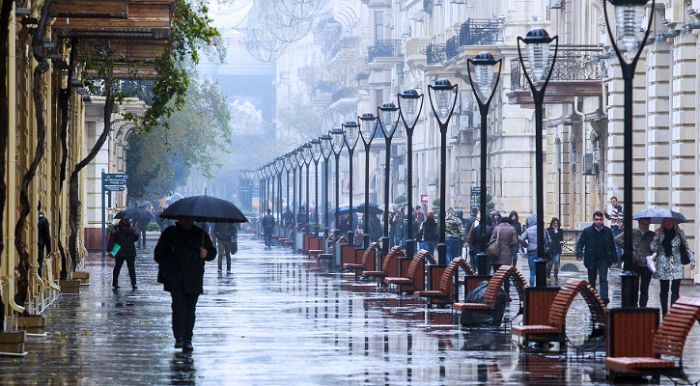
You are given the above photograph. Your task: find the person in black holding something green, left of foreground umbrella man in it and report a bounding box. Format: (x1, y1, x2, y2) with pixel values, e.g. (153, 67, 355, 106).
(107, 218, 139, 291)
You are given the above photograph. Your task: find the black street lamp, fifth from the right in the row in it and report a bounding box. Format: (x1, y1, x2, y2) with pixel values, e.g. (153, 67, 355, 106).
(398, 89, 423, 257)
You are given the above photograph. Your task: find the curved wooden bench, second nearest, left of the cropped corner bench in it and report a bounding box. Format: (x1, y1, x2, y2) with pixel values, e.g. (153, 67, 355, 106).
(512, 278, 607, 349)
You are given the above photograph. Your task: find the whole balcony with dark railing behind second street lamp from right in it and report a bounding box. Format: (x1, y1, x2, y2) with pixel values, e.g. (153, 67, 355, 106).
(508, 46, 606, 105)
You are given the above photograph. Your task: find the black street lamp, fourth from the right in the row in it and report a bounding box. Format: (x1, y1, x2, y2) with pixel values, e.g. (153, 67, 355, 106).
(428, 79, 459, 264)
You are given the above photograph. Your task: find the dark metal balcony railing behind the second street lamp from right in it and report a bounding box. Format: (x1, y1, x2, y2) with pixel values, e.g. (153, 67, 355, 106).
(510, 46, 605, 90)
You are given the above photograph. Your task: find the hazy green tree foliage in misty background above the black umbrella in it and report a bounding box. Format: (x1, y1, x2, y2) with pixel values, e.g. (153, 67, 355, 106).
(127, 79, 231, 200)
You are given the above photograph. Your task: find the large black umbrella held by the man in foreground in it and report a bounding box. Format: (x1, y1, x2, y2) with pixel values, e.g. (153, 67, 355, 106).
(160, 196, 248, 223)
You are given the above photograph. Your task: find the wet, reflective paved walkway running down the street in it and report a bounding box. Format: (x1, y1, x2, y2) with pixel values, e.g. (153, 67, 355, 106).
(0, 234, 700, 385)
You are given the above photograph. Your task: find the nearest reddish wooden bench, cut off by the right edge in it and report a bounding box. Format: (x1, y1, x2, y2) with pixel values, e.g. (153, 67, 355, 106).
(605, 296, 700, 381)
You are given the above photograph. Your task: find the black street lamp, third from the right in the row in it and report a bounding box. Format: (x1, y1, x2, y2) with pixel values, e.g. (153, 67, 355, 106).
(467, 52, 503, 275)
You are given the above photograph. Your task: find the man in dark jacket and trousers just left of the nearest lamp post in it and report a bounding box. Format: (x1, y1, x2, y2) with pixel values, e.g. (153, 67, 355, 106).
(576, 211, 616, 305)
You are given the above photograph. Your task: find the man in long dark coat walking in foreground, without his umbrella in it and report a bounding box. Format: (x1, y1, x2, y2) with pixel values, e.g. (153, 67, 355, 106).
(154, 217, 216, 352)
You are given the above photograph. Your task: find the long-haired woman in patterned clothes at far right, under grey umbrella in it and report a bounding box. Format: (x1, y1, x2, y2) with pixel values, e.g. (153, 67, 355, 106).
(651, 217, 695, 315)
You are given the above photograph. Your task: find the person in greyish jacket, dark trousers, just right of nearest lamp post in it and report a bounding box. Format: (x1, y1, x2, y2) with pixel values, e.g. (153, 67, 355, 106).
(615, 217, 656, 307)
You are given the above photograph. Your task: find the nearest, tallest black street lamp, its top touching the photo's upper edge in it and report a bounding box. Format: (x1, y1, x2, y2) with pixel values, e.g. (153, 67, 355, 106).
(603, 0, 656, 307)
